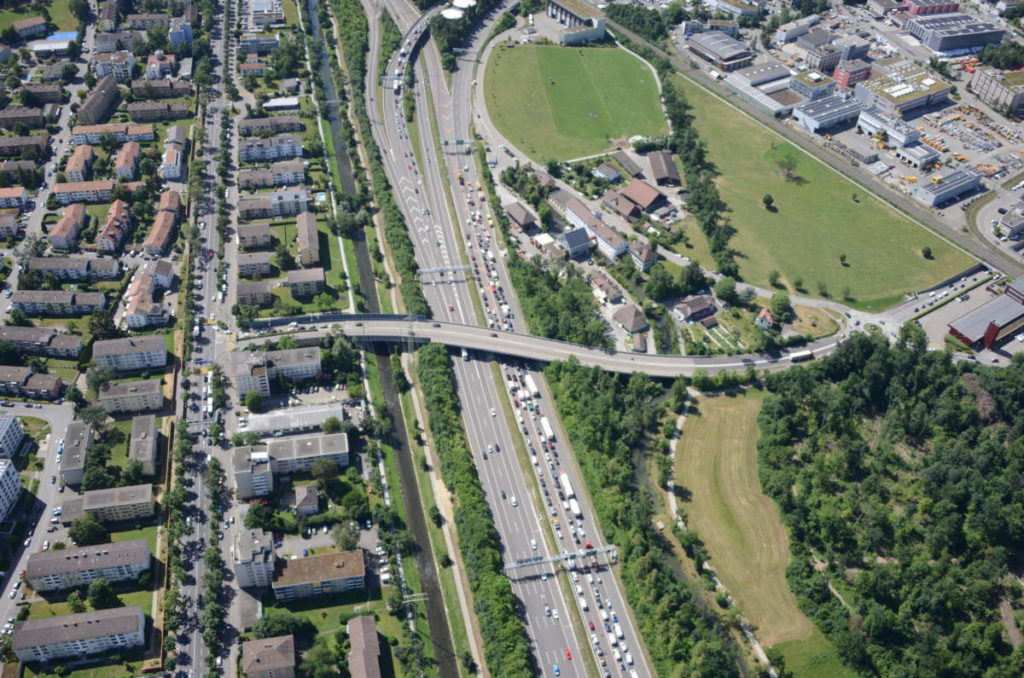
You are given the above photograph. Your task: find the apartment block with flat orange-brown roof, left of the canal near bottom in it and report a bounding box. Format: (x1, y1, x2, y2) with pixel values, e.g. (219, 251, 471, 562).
(272, 549, 367, 602)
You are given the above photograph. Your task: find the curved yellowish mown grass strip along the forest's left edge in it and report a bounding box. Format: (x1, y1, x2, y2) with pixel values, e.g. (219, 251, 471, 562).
(676, 392, 852, 678)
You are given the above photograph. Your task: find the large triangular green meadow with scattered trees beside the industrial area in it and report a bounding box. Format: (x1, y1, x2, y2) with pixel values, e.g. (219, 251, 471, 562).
(676, 76, 971, 310)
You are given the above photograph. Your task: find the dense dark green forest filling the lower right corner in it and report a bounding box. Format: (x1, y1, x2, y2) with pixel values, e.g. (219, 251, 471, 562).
(759, 326, 1024, 678)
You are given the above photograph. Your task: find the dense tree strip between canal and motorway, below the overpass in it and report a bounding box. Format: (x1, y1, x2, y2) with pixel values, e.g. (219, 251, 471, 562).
(417, 344, 538, 678)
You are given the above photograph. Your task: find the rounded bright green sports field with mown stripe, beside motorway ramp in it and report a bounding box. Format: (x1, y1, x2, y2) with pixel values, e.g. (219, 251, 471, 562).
(484, 45, 668, 163)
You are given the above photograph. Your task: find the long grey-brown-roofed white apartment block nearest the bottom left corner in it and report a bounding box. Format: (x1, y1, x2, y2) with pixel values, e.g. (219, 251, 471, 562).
(10, 605, 145, 662)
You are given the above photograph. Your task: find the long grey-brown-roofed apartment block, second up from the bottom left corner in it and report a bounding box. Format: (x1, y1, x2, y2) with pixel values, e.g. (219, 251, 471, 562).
(25, 539, 152, 592)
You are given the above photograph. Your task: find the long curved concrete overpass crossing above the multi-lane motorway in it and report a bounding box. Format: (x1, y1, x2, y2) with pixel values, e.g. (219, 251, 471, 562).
(253, 313, 842, 377)
